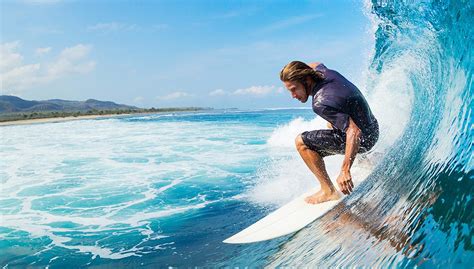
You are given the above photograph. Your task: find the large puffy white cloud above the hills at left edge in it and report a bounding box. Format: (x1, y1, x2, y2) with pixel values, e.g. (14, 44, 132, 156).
(0, 42, 95, 93)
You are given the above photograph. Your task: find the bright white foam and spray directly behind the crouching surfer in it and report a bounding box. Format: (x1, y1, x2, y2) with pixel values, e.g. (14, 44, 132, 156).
(247, 33, 416, 206)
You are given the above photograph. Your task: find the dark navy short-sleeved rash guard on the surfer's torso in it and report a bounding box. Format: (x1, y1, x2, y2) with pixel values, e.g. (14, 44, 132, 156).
(312, 64, 378, 138)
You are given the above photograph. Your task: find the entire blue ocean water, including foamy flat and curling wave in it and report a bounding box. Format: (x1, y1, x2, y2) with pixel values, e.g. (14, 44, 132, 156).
(0, 0, 474, 268)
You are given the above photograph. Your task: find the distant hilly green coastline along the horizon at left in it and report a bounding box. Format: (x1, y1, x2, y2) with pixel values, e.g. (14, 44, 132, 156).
(0, 95, 212, 122)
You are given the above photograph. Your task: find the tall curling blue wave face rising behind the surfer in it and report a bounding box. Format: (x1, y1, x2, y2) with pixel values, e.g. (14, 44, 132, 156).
(270, 0, 474, 268)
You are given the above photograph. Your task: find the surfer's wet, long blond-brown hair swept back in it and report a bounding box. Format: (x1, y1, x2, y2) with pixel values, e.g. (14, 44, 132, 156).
(280, 61, 324, 85)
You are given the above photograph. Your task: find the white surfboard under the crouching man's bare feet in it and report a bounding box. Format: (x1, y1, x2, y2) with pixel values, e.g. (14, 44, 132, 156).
(223, 163, 370, 244)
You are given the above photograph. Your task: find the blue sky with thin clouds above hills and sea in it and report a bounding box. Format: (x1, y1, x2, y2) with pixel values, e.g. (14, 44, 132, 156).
(0, 0, 373, 109)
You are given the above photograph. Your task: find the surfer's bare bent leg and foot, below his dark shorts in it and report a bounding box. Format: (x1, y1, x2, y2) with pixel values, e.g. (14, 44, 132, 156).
(295, 135, 340, 204)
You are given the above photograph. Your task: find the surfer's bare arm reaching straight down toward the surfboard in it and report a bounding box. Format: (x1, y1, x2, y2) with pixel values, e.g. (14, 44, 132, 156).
(337, 117, 362, 194)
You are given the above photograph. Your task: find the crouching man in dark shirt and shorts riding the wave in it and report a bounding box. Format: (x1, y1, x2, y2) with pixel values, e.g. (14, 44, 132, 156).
(280, 61, 379, 204)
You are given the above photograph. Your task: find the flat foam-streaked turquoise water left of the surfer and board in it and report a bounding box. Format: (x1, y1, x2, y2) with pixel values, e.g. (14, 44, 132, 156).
(0, 109, 336, 267)
